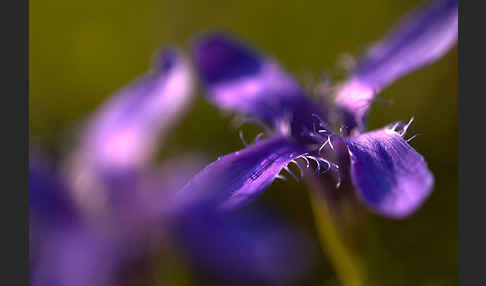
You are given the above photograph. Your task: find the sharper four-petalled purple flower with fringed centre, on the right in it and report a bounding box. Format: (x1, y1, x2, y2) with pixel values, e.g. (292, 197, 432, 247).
(178, 0, 458, 218)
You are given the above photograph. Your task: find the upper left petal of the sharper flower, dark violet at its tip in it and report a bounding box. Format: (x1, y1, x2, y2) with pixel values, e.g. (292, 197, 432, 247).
(193, 34, 325, 136)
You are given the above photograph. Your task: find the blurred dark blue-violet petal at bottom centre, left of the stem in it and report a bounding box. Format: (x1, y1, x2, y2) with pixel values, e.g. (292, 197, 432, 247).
(175, 208, 315, 285)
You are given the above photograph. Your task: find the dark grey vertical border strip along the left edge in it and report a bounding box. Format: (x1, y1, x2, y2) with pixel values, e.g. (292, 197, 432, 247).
(0, 0, 29, 285)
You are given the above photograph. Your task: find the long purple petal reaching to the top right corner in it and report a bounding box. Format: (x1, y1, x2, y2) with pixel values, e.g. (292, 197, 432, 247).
(336, 0, 458, 128)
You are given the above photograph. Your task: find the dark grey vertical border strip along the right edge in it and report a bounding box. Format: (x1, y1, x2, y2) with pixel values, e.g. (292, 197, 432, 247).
(458, 0, 486, 285)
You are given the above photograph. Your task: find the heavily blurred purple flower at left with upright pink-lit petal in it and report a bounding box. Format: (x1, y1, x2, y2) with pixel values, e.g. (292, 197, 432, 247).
(29, 50, 193, 285)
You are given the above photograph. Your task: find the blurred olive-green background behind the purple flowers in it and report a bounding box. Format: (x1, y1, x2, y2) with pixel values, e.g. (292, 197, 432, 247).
(29, 0, 458, 286)
